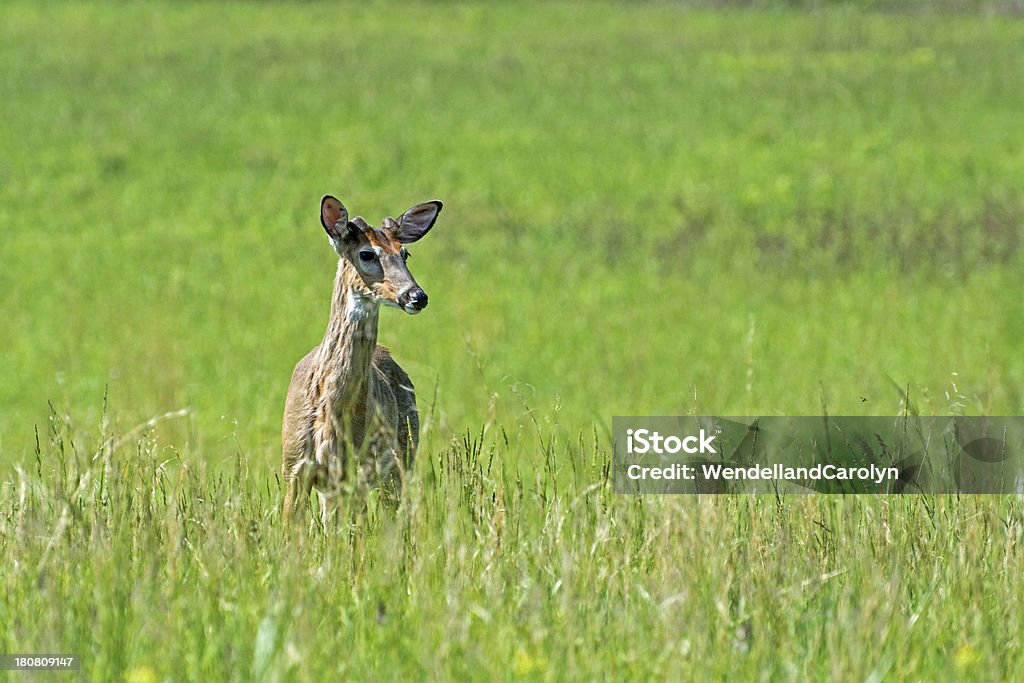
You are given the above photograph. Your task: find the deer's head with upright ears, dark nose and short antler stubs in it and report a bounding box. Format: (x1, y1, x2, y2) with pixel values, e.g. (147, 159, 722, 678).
(321, 195, 442, 315)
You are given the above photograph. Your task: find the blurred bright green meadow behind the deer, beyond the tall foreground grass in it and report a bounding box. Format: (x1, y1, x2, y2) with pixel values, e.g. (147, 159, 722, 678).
(0, 2, 1024, 466)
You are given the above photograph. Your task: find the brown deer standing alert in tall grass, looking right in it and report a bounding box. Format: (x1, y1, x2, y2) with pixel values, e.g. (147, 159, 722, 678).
(281, 195, 443, 530)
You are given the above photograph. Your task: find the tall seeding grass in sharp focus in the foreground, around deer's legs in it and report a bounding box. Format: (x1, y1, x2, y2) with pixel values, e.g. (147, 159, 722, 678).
(0, 409, 1024, 680)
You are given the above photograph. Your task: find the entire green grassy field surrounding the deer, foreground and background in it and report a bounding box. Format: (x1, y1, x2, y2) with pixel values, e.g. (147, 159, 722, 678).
(0, 1, 1024, 682)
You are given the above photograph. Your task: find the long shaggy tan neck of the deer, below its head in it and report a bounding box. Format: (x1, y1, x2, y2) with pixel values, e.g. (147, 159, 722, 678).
(314, 259, 379, 413)
